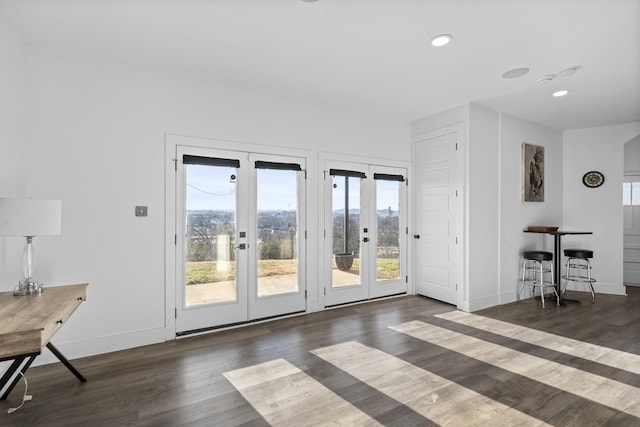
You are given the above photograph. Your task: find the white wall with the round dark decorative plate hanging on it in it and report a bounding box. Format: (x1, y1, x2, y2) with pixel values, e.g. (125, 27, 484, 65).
(563, 122, 640, 294)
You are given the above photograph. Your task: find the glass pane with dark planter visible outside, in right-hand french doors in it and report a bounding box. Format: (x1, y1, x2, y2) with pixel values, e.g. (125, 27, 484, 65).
(331, 175, 362, 288)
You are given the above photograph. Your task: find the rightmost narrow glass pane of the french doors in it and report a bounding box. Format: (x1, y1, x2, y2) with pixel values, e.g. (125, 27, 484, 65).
(376, 179, 404, 281)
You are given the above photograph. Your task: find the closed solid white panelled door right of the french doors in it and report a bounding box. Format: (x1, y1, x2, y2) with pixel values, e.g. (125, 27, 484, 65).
(414, 131, 462, 304)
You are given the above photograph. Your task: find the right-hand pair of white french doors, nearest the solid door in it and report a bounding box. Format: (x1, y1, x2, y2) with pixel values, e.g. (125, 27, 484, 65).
(324, 161, 407, 306)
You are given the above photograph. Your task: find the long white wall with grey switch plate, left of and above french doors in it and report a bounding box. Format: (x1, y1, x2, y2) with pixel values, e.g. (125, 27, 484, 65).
(0, 40, 410, 361)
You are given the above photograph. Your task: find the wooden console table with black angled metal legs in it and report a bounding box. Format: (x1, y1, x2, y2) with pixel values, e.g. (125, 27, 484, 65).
(0, 283, 89, 400)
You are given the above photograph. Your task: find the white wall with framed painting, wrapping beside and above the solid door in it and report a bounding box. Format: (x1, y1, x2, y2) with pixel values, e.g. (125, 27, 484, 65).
(412, 104, 563, 311)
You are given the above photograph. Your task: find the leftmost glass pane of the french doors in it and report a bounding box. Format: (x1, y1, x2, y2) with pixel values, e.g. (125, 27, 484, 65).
(184, 164, 238, 307)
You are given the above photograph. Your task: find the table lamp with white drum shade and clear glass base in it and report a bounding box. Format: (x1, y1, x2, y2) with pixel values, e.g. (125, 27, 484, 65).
(0, 198, 62, 295)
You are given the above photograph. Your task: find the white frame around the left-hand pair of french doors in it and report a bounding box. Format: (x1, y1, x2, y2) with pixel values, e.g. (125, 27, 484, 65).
(164, 133, 319, 340)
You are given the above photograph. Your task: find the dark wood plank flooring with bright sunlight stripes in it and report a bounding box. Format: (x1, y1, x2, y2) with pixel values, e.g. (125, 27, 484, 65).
(0, 287, 640, 426)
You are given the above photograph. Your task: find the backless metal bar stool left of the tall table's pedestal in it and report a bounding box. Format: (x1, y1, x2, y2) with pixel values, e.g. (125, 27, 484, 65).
(516, 251, 560, 308)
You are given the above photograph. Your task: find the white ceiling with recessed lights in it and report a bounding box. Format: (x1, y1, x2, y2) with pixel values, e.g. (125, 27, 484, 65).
(0, 0, 640, 130)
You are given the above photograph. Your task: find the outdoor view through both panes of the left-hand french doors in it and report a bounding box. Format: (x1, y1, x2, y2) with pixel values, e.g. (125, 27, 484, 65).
(185, 165, 299, 305)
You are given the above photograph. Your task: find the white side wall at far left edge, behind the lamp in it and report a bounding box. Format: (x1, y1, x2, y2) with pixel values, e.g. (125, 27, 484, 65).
(0, 13, 28, 290)
